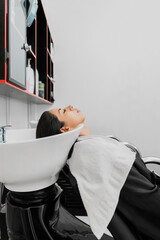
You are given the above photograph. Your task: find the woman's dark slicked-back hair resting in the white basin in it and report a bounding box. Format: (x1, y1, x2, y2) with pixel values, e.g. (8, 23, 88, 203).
(36, 111, 64, 138)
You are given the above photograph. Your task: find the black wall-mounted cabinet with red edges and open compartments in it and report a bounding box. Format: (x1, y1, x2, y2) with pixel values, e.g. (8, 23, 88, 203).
(0, 0, 54, 104)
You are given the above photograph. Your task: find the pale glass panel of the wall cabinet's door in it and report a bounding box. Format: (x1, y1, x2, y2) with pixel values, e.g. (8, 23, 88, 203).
(9, 0, 26, 89)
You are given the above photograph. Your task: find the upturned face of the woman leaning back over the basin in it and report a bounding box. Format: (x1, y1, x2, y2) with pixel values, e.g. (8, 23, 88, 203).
(49, 105, 85, 129)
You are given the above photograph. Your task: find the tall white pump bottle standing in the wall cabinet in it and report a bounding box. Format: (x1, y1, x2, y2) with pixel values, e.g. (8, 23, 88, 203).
(26, 58, 34, 93)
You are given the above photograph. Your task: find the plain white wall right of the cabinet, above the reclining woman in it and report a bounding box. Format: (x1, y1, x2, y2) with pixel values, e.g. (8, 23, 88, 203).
(43, 0, 160, 156)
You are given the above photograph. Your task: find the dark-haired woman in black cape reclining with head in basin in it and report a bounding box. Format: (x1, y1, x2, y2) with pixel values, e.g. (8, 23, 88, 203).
(36, 106, 160, 240)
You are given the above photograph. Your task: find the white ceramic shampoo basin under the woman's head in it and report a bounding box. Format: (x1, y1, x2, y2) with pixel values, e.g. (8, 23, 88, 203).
(0, 124, 83, 192)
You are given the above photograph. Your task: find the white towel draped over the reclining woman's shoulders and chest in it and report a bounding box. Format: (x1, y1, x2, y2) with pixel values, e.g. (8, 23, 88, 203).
(69, 136, 135, 239)
